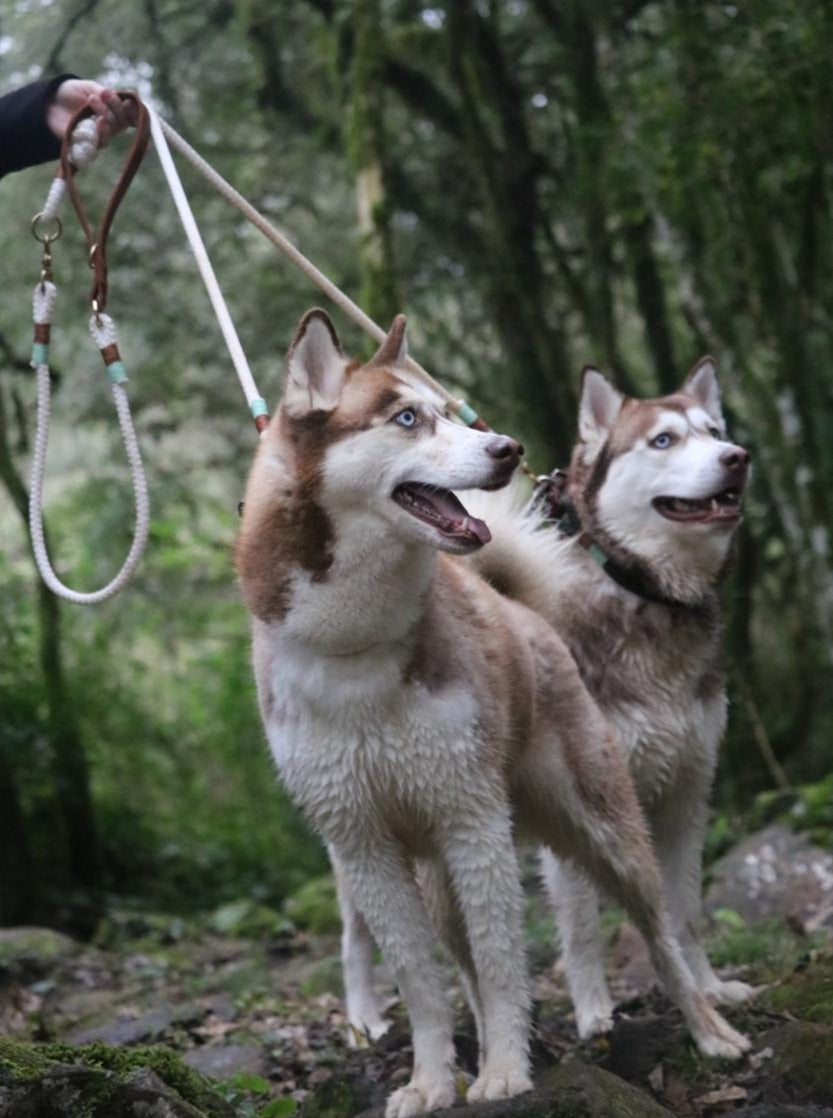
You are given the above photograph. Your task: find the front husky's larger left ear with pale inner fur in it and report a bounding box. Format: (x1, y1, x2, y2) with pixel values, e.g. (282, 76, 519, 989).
(284, 307, 347, 415)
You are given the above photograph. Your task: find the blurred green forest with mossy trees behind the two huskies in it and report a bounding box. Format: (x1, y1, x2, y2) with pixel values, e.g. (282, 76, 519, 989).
(0, 0, 833, 931)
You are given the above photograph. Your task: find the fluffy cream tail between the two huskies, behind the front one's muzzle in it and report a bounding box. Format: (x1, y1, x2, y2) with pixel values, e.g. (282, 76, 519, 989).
(463, 480, 575, 623)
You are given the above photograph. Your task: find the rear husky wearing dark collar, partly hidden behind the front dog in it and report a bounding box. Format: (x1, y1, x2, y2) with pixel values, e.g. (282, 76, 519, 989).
(471, 358, 754, 1036)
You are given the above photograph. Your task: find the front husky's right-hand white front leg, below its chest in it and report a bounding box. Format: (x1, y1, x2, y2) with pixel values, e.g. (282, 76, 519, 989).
(442, 788, 532, 1101)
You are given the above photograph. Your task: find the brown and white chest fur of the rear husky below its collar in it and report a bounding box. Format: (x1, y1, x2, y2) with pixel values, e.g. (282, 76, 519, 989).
(550, 556, 726, 807)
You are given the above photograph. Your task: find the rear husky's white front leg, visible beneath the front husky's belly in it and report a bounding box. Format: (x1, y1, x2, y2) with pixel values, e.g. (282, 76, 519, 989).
(539, 846, 613, 1040)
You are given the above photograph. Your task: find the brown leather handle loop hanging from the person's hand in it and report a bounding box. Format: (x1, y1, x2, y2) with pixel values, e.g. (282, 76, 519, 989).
(60, 89, 150, 313)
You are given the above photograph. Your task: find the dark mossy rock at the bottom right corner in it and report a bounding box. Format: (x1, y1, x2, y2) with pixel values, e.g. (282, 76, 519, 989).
(760, 1021, 833, 1107)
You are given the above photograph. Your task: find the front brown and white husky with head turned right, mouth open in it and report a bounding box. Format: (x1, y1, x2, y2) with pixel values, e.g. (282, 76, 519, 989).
(237, 310, 748, 1118)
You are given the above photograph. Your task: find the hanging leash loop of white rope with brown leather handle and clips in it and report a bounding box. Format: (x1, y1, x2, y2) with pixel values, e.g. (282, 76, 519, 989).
(29, 94, 150, 606)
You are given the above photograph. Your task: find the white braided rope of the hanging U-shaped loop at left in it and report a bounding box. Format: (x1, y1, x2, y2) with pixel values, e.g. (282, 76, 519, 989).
(29, 283, 150, 606)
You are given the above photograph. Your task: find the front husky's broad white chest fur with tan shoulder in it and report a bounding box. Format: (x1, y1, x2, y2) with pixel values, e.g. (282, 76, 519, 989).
(254, 560, 529, 851)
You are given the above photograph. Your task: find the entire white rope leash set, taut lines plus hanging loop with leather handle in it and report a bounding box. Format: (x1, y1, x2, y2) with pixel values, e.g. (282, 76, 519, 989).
(29, 91, 536, 605)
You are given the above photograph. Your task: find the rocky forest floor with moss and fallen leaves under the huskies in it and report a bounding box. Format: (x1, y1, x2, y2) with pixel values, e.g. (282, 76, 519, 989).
(0, 825, 833, 1118)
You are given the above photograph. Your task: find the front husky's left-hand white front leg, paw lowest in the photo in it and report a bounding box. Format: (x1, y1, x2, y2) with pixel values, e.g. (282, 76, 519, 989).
(334, 843, 454, 1118)
